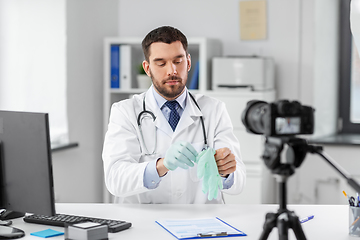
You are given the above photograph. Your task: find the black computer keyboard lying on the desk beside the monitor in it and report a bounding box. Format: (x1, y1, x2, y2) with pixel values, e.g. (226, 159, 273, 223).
(23, 214, 131, 233)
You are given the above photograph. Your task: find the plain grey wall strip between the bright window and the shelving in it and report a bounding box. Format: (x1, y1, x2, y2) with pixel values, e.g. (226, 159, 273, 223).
(53, 0, 118, 202)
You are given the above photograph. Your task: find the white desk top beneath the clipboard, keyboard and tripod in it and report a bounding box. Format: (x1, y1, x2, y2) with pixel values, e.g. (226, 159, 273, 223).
(13, 203, 348, 240)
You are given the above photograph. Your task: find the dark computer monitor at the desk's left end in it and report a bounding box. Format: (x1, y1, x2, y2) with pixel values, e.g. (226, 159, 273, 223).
(0, 111, 55, 219)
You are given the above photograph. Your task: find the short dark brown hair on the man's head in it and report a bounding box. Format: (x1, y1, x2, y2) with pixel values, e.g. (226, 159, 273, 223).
(142, 26, 188, 62)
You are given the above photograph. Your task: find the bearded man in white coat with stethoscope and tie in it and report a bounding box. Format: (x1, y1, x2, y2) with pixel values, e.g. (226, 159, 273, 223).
(102, 26, 246, 204)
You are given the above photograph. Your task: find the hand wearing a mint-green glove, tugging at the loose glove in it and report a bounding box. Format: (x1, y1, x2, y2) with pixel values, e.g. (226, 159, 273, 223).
(164, 142, 197, 171)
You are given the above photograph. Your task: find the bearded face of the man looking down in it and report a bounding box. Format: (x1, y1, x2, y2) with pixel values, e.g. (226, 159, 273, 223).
(143, 41, 191, 100)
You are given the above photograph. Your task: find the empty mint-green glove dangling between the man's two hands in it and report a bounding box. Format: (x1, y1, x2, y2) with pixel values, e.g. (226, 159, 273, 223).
(196, 148, 223, 201)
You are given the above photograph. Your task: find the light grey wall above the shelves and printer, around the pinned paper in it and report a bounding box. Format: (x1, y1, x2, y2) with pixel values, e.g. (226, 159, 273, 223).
(119, 0, 339, 135)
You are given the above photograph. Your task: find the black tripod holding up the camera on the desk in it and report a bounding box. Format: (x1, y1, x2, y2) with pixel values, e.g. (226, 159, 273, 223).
(260, 137, 360, 240)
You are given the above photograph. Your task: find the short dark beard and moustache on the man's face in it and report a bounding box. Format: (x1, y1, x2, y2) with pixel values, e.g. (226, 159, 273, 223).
(150, 70, 187, 99)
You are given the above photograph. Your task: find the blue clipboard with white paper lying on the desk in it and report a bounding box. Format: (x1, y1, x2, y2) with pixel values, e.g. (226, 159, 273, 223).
(155, 217, 247, 239)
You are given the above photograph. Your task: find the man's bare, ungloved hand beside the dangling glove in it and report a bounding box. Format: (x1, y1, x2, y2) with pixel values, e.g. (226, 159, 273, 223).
(215, 148, 236, 177)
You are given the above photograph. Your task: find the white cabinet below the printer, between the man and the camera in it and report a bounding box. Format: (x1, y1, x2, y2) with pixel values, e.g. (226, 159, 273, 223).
(206, 90, 275, 204)
